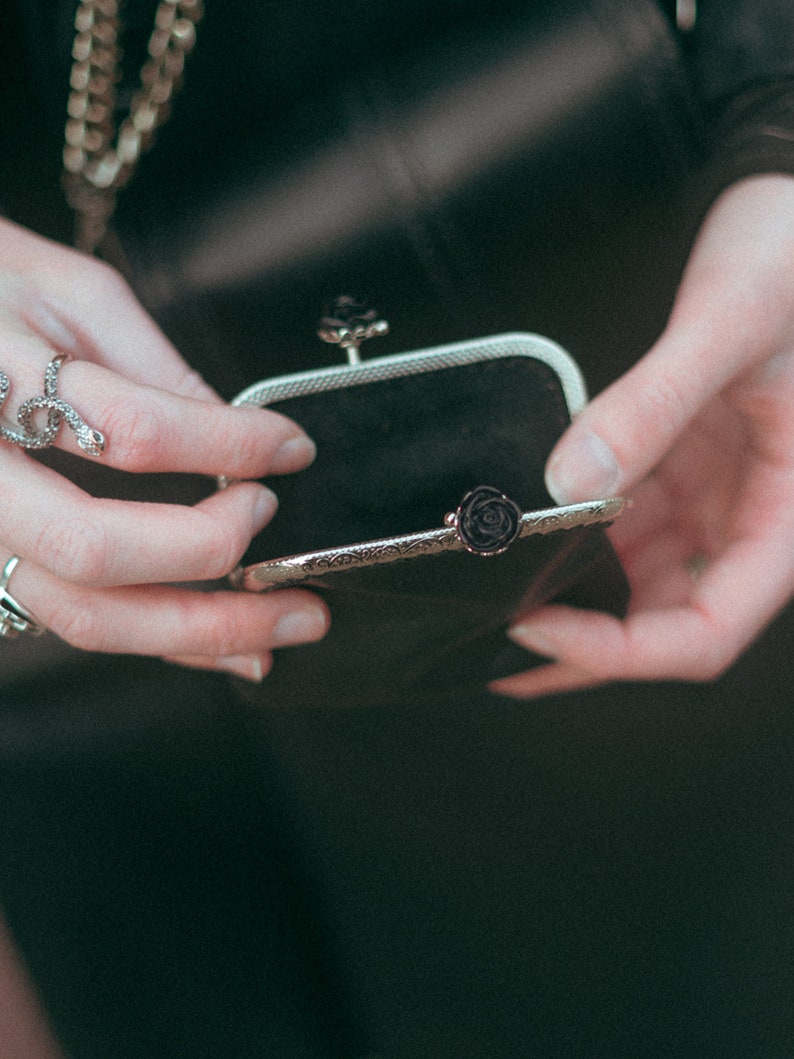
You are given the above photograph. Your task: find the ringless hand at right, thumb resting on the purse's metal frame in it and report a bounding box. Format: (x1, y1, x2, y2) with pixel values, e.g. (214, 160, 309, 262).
(492, 176, 794, 697)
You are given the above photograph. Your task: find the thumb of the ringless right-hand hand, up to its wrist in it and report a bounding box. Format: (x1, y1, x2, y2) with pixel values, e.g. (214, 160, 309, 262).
(546, 178, 794, 503)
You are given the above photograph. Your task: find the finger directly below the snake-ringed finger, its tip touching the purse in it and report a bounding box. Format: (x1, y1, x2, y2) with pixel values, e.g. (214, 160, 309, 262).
(0, 452, 277, 586)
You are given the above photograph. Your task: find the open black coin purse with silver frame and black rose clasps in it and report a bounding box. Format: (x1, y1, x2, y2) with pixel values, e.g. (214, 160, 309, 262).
(220, 318, 629, 706)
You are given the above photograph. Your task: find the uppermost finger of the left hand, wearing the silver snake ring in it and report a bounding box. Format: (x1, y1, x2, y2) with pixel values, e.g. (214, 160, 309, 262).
(0, 340, 315, 478)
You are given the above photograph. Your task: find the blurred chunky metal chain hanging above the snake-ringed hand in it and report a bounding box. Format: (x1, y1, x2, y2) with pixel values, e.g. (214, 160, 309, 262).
(64, 0, 203, 253)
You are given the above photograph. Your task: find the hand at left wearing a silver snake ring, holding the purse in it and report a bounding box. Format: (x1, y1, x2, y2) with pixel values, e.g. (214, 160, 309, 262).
(0, 221, 328, 679)
